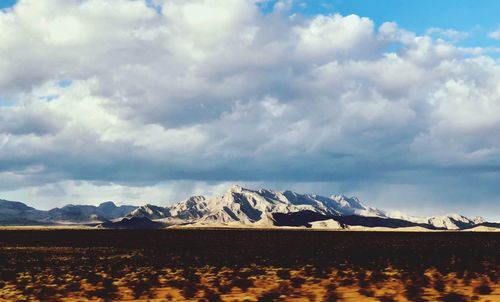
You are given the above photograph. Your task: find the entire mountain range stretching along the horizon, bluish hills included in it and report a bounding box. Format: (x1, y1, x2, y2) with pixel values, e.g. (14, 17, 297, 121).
(0, 185, 500, 231)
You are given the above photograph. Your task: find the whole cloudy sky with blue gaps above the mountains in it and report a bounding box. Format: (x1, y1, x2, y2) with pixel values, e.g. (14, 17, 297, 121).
(0, 0, 500, 221)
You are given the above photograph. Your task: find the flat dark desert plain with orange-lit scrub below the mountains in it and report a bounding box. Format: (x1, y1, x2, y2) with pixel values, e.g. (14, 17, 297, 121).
(0, 229, 500, 302)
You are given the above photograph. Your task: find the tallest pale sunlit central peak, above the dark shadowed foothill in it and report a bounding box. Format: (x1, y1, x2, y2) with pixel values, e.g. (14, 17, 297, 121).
(158, 185, 392, 227)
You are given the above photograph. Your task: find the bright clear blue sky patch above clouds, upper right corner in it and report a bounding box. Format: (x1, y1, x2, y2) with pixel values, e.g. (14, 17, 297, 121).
(258, 0, 500, 47)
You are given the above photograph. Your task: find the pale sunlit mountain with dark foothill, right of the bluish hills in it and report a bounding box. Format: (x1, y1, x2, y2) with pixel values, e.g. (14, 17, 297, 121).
(121, 185, 480, 230)
